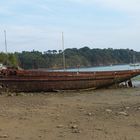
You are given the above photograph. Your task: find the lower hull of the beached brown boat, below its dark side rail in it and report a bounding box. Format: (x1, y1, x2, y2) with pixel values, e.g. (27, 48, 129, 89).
(1, 79, 132, 92)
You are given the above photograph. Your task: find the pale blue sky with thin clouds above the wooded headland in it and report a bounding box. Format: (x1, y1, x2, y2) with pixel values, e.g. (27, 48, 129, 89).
(0, 0, 140, 52)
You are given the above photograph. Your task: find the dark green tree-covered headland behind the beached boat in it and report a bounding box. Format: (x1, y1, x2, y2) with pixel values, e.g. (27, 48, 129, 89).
(0, 47, 140, 69)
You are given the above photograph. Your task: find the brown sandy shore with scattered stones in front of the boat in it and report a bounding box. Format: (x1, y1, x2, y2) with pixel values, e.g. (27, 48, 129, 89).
(0, 88, 140, 140)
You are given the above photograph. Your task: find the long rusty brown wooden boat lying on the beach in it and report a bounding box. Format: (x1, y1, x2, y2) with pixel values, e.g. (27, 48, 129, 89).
(0, 69, 140, 92)
